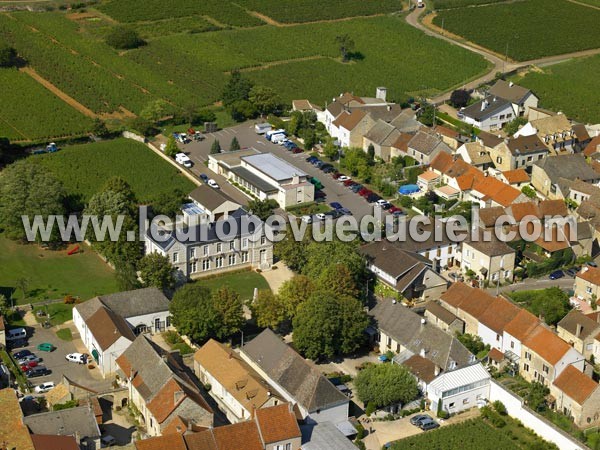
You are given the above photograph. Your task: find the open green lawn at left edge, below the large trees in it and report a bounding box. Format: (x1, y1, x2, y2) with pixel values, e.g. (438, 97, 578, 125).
(0, 235, 118, 307)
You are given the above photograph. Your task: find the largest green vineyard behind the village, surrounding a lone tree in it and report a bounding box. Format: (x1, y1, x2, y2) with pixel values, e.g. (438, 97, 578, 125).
(127, 17, 487, 103)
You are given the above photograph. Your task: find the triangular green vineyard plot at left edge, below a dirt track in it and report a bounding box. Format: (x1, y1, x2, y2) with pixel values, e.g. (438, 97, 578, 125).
(0, 69, 93, 141)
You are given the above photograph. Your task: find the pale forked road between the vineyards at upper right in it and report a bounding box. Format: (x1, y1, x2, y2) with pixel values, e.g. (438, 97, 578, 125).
(406, 2, 600, 104)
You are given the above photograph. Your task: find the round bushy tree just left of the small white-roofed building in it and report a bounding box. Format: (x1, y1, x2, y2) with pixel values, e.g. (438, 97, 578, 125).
(354, 364, 419, 408)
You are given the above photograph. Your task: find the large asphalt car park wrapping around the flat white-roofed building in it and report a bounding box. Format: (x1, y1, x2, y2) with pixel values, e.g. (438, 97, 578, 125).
(172, 122, 394, 219)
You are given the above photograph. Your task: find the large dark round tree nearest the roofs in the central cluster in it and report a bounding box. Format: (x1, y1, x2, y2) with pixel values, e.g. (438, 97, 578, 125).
(293, 292, 369, 359)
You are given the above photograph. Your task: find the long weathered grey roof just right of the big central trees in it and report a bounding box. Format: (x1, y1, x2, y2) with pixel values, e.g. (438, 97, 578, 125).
(369, 299, 474, 370)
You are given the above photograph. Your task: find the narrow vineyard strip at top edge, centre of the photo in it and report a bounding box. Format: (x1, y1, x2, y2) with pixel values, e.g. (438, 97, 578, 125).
(239, 0, 402, 23)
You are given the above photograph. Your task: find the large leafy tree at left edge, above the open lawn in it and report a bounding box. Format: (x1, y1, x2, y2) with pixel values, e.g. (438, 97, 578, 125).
(0, 160, 65, 242)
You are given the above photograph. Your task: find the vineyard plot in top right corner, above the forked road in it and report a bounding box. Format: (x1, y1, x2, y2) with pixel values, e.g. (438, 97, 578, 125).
(433, 0, 600, 61)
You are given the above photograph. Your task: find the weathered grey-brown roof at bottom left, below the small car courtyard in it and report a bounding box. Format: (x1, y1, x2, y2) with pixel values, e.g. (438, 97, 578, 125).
(23, 406, 100, 440)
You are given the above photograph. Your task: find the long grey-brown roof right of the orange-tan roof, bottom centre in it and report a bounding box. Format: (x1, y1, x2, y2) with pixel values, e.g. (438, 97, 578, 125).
(242, 328, 349, 412)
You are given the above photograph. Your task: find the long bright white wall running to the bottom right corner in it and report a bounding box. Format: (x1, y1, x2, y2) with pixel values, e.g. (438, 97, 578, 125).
(490, 380, 587, 450)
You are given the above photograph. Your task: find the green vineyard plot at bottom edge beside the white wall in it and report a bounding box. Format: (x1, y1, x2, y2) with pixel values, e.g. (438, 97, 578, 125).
(391, 416, 556, 450)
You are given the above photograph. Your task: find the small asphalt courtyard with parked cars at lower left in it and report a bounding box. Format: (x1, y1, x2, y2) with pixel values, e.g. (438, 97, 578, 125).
(10, 325, 111, 391)
